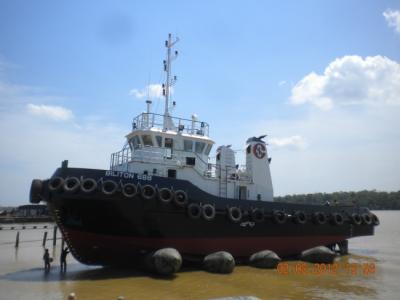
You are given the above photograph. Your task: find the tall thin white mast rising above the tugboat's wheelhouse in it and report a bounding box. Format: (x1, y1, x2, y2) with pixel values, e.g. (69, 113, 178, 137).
(162, 34, 179, 130)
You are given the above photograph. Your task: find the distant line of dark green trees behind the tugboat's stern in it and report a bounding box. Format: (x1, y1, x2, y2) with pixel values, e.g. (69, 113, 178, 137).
(274, 190, 400, 210)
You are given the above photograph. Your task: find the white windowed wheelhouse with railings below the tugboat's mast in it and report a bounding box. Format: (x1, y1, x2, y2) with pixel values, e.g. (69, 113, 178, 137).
(111, 112, 214, 177)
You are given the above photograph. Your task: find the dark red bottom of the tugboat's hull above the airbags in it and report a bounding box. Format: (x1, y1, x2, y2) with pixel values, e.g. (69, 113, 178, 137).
(65, 230, 347, 264)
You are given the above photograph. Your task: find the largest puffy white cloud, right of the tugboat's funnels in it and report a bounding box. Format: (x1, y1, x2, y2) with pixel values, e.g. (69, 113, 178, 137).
(290, 55, 400, 110)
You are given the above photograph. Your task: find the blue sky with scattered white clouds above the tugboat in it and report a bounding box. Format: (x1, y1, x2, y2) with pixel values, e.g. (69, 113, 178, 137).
(0, 0, 400, 206)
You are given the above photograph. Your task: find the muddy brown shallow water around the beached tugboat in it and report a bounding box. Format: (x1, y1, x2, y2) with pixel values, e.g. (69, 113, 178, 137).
(0, 211, 400, 300)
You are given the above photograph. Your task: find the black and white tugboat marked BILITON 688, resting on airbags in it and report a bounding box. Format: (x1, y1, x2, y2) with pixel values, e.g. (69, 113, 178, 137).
(30, 35, 379, 265)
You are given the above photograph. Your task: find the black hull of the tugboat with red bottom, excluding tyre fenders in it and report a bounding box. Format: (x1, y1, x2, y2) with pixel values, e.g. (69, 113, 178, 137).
(31, 168, 374, 265)
